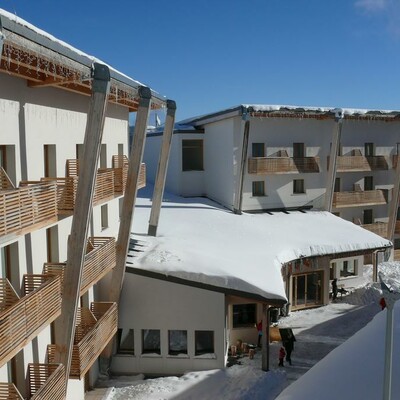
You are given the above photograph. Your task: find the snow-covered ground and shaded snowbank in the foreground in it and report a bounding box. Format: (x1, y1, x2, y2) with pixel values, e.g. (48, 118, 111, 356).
(92, 263, 400, 400)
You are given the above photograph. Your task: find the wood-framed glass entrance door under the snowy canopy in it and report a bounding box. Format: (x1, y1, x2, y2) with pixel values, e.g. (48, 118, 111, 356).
(292, 271, 323, 308)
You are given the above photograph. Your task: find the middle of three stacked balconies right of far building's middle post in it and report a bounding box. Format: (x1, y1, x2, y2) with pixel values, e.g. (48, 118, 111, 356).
(332, 189, 388, 208)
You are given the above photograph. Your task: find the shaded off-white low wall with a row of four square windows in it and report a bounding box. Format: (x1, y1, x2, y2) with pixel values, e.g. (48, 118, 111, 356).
(111, 273, 225, 375)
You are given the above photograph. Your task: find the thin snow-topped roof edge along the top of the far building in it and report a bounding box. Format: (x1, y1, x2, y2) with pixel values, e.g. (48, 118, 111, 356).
(180, 104, 400, 126)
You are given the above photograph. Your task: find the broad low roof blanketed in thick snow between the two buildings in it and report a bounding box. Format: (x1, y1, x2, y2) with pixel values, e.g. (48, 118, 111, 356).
(127, 185, 391, 301)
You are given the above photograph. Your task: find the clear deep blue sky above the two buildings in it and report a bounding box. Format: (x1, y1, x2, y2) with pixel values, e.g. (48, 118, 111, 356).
(0, 0, 400, 120)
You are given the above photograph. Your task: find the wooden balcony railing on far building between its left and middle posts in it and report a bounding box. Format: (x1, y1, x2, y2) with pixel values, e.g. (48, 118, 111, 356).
(248, 157, 319, 175)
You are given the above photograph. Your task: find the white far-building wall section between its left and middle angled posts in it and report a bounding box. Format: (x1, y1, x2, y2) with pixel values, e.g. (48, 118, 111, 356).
(243, 117, 334, 210)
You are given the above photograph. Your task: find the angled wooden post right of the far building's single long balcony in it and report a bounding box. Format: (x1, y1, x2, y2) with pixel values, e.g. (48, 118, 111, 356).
(324, 110, 343, 212)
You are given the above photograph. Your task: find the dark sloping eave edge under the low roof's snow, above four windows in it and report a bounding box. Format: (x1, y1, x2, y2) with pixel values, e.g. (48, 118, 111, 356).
(126, 266, 287, 307)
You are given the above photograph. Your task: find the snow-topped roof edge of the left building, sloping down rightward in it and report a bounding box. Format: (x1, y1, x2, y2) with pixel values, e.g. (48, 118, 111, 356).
(0, 8, 165, 108)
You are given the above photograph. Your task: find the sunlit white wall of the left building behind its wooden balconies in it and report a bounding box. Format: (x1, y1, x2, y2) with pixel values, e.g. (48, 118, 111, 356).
(0, 74, 129, 400)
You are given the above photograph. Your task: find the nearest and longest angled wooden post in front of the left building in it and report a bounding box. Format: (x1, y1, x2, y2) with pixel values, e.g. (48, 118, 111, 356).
(55, 63, 110, 384)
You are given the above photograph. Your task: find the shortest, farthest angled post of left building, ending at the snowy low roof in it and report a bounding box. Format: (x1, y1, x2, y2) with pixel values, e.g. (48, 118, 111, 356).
(148, 100, 176, 236)
